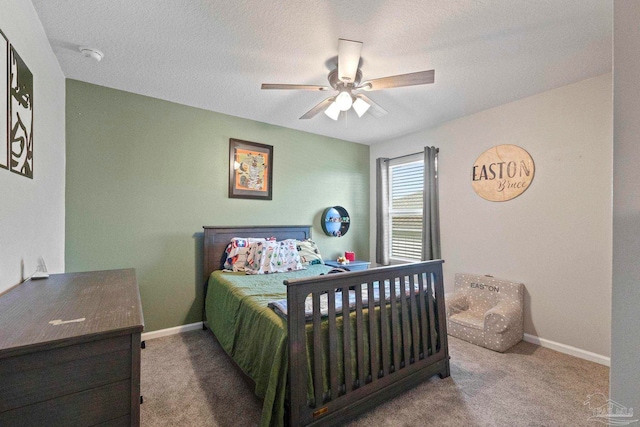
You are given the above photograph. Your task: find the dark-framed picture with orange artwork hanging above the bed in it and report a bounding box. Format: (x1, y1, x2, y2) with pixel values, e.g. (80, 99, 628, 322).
(229, 138, 273, 200)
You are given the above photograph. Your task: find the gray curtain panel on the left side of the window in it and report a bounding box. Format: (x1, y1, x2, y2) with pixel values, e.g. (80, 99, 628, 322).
(376, 157, 389, 265)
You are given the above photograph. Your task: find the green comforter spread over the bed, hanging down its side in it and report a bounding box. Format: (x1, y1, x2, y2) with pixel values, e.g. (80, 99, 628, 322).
(206, 265, 331, 427)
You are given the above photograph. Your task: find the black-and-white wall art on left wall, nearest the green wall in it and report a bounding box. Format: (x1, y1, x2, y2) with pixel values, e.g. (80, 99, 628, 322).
(9, 46, 33, 178)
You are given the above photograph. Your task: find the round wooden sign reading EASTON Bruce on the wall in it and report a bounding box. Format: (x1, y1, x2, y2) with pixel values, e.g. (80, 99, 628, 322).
(471, 144, 535, 202)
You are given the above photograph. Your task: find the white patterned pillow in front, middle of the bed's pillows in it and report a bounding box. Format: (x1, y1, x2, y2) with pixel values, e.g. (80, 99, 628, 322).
(245, 239, 303, 274)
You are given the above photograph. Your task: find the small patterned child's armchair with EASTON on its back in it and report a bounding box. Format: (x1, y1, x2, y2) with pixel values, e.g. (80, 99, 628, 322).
(445, 274, 524, 352)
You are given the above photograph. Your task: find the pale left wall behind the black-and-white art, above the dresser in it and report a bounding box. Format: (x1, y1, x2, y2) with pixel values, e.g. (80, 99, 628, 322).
(0, 0, 65, 292)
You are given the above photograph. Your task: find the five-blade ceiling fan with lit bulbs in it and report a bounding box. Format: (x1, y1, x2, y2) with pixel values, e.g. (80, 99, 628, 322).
(262, 39, 435, 120)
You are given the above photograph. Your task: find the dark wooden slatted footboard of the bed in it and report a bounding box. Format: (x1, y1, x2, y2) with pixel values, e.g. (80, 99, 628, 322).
(284, 260, 449, 426)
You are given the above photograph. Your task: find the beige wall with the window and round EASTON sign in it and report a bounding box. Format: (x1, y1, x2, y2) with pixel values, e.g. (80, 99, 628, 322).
(370, 74, 612, 363)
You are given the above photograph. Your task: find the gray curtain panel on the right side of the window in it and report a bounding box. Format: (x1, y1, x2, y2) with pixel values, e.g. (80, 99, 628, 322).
(422, 147, 441, 261)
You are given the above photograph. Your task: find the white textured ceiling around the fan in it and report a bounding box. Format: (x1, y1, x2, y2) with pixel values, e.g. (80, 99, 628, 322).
(33, 0, 613, 144)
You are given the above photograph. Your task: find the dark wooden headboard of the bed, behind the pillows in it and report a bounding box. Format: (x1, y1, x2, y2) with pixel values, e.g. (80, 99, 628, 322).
(202, 225, 311, 283)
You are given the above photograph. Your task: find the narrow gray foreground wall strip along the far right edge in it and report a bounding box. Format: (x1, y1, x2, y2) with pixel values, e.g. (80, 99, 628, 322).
(610, 0, 640, 419)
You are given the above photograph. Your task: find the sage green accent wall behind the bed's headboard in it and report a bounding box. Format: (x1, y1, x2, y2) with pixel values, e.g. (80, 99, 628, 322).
(65, 80, 369, 331)
